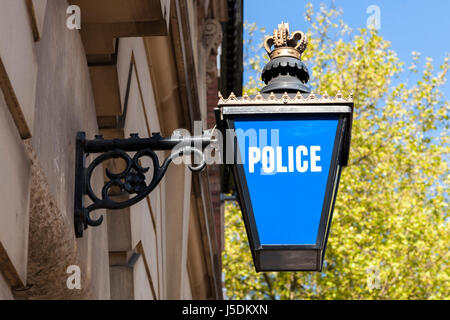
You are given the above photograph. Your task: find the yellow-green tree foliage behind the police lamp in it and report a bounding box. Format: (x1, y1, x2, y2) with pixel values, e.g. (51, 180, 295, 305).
(223, 4, 450, 299)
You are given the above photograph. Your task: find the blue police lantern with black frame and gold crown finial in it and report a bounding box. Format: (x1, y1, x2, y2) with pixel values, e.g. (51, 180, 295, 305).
(216, 23, 353, 272)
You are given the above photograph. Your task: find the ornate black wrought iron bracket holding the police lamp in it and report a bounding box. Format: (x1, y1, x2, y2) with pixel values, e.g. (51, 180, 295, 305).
(74, 132, 213, 238)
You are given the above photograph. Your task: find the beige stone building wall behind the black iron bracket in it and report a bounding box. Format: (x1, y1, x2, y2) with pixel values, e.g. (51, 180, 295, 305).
(0, 0, 236, 299)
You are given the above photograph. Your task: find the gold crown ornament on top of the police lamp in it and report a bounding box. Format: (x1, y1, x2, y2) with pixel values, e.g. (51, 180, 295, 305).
(264, 22, 308, 59)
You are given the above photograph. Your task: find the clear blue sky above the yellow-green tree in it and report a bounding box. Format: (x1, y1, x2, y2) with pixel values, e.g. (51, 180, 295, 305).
(244, 0, 450, 99)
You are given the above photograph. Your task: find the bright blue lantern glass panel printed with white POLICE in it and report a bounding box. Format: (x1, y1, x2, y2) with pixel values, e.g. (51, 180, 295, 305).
(234, 115, 339, 245)
